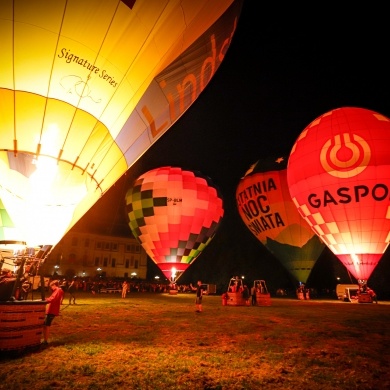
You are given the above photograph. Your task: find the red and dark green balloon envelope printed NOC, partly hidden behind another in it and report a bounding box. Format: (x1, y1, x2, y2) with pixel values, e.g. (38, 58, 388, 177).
(236, 157, 325, 283)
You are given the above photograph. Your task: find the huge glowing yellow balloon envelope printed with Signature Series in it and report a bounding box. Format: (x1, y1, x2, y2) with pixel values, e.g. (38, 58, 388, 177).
(0, 0, 241, 245)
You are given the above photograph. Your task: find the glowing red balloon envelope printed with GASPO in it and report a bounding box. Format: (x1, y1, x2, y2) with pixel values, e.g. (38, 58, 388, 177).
(287, 107, 390, 283)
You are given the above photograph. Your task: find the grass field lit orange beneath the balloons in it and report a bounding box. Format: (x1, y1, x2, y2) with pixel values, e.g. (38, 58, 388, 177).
(0, 293, 390, 390)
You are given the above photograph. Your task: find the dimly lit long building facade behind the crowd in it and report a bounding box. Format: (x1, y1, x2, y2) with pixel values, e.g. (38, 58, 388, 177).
(45, 232, 147, 279)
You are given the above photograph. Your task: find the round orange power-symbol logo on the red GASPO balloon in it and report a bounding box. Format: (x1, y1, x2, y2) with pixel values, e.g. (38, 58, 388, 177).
(320, 133, 371, 177)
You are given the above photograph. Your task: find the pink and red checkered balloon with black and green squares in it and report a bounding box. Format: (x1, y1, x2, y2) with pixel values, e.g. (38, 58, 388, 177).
(125, 166, 224, 282)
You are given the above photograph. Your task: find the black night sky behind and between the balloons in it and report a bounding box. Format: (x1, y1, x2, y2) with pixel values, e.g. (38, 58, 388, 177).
(72, 0, 390, 292)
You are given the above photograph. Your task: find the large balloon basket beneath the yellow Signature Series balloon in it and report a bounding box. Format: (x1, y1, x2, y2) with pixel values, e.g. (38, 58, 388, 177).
(0, 301, 46, 352)
